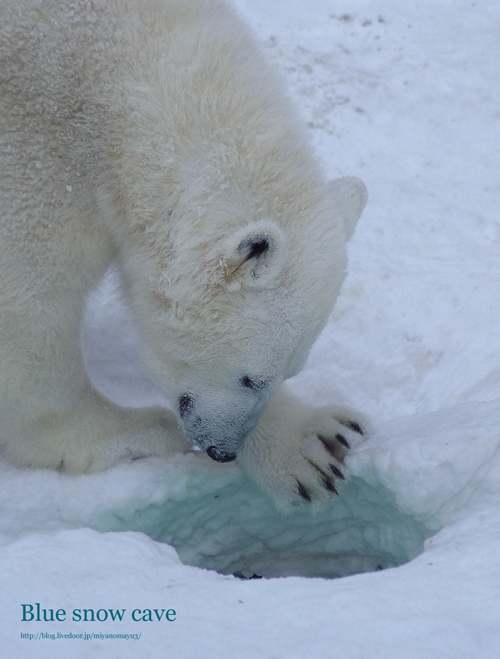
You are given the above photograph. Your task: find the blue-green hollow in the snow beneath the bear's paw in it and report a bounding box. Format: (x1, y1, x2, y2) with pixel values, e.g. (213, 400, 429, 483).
(98, 474, 436, 579)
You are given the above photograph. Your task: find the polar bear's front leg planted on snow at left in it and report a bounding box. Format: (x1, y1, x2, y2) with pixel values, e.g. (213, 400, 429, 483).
(0, 266, 191, 473)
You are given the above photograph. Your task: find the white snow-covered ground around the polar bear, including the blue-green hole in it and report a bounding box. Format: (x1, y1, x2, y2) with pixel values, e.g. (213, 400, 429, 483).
(0, 0, 500, 659)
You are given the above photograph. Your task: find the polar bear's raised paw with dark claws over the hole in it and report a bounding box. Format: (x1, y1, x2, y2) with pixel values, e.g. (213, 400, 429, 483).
(238, 385, 366, 505)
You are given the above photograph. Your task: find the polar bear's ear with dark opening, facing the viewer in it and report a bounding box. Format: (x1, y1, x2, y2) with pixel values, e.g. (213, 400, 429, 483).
(223, 220, 286, 290)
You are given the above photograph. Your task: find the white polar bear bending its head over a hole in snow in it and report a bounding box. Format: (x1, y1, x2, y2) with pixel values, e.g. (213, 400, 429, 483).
(0, 0, 366, 503)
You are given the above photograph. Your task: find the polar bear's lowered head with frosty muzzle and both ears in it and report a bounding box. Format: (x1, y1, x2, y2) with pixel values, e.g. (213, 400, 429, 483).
(119, 178, 366, 462)
